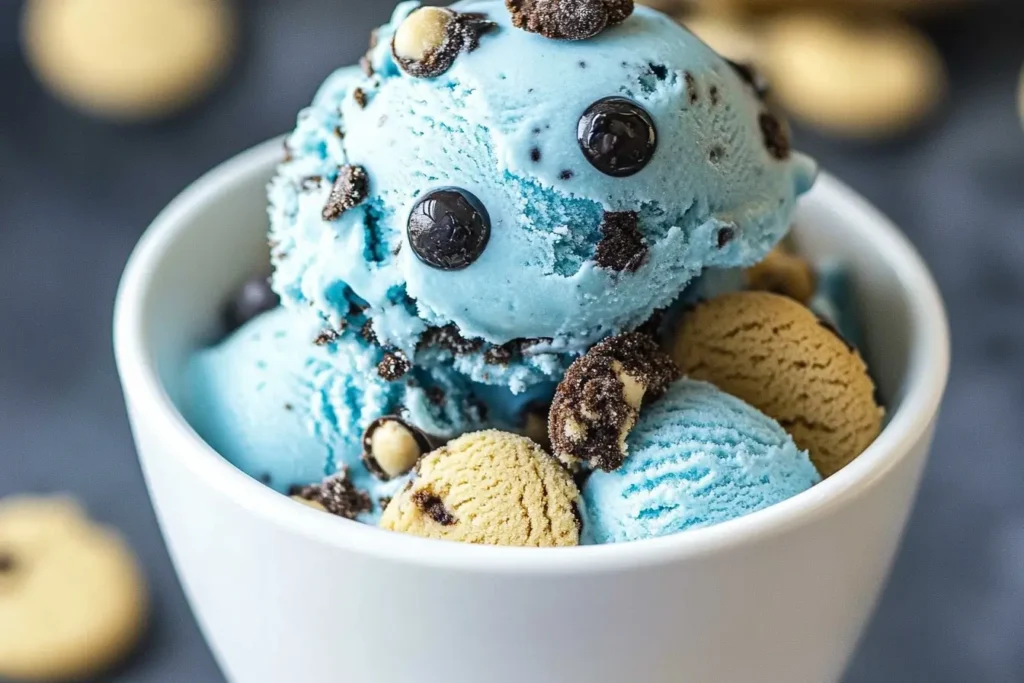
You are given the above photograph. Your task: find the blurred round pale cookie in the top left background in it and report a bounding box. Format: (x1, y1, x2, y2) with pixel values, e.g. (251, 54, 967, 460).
(23, 0, 236, 120)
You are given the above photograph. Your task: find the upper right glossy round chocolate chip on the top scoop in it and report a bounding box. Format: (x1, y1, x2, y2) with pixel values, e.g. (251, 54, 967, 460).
(577, 97, 657, 178)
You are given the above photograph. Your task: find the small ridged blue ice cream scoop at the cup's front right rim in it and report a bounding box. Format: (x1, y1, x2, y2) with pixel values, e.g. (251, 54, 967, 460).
(583, 379, 820, 543)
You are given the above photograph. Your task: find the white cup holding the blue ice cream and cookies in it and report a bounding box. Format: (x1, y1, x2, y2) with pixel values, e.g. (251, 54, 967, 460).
(115, 140, 949, 683)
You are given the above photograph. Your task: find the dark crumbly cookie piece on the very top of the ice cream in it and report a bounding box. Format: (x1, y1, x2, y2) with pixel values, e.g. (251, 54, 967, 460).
(505, 0, 633, 40)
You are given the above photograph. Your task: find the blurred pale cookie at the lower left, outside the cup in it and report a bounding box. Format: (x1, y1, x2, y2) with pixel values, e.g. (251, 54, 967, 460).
(0, 498, 146, 681)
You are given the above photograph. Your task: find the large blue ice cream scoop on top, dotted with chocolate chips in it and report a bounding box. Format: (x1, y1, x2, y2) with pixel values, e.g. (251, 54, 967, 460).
(269, 0, 815, 390)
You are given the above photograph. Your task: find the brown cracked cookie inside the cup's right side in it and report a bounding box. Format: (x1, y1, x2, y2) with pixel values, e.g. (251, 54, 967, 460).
(673, 292, 883, 476)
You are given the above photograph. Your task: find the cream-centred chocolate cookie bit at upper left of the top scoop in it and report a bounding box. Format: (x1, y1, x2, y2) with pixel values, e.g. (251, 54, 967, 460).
(391, 7, 496, 78)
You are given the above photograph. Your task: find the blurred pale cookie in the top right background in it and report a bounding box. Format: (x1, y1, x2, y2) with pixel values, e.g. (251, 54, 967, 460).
(762, 13, 946, 138)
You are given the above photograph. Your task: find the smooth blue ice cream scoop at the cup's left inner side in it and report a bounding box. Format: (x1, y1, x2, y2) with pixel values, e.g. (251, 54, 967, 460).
(182, 308, 483, 518)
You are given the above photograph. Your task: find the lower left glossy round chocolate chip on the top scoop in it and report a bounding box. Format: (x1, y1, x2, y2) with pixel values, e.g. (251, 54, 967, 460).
(408, 187, 490, 270)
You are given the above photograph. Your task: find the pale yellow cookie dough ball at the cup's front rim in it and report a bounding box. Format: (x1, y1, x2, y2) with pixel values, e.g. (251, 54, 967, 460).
(381, 430, 581, 547)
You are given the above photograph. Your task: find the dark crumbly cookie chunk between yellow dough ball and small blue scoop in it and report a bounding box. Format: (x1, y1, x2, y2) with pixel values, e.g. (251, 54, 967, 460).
(548, 332, 679, 472)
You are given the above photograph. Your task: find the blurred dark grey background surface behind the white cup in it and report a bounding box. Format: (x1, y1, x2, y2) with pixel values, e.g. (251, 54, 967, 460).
(0, 0, 1024, 683)
